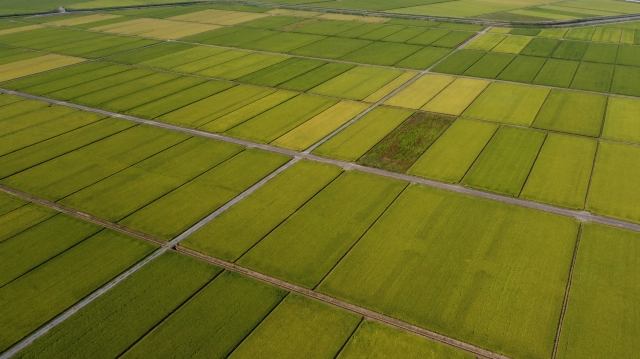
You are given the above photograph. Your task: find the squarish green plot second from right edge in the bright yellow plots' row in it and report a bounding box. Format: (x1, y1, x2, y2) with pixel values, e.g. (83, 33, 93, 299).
(533, 90, 607, 137)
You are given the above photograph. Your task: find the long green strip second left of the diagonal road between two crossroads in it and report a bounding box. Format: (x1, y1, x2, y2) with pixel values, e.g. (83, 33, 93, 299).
(60, 137, 243, 222)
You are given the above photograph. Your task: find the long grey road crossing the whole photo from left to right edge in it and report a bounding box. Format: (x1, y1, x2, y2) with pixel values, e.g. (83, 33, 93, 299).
(0, 88, 640, 235)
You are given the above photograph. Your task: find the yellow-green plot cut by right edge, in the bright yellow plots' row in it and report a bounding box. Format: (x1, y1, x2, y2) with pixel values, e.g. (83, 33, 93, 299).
(602, 97, 640, 144)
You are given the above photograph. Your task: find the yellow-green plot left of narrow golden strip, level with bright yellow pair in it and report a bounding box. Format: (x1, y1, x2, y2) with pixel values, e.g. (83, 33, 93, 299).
(309, 66, 403, 100)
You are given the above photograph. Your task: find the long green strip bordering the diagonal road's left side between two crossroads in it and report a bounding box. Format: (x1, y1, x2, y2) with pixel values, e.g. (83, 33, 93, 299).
(119, 149, 289, 240)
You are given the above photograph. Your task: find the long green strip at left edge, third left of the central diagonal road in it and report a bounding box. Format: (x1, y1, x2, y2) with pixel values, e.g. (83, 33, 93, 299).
(0, 126, 188, 201)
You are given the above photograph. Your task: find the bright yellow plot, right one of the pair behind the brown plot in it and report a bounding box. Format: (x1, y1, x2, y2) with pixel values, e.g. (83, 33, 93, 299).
(421, 78, 491, 116)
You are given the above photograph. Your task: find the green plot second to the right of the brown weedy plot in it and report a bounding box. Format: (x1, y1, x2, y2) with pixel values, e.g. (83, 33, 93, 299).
(462, 126, 546, 196)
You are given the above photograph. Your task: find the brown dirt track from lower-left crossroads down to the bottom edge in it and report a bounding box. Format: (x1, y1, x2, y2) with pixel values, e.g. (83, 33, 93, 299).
(176, 246, 508, 359)
